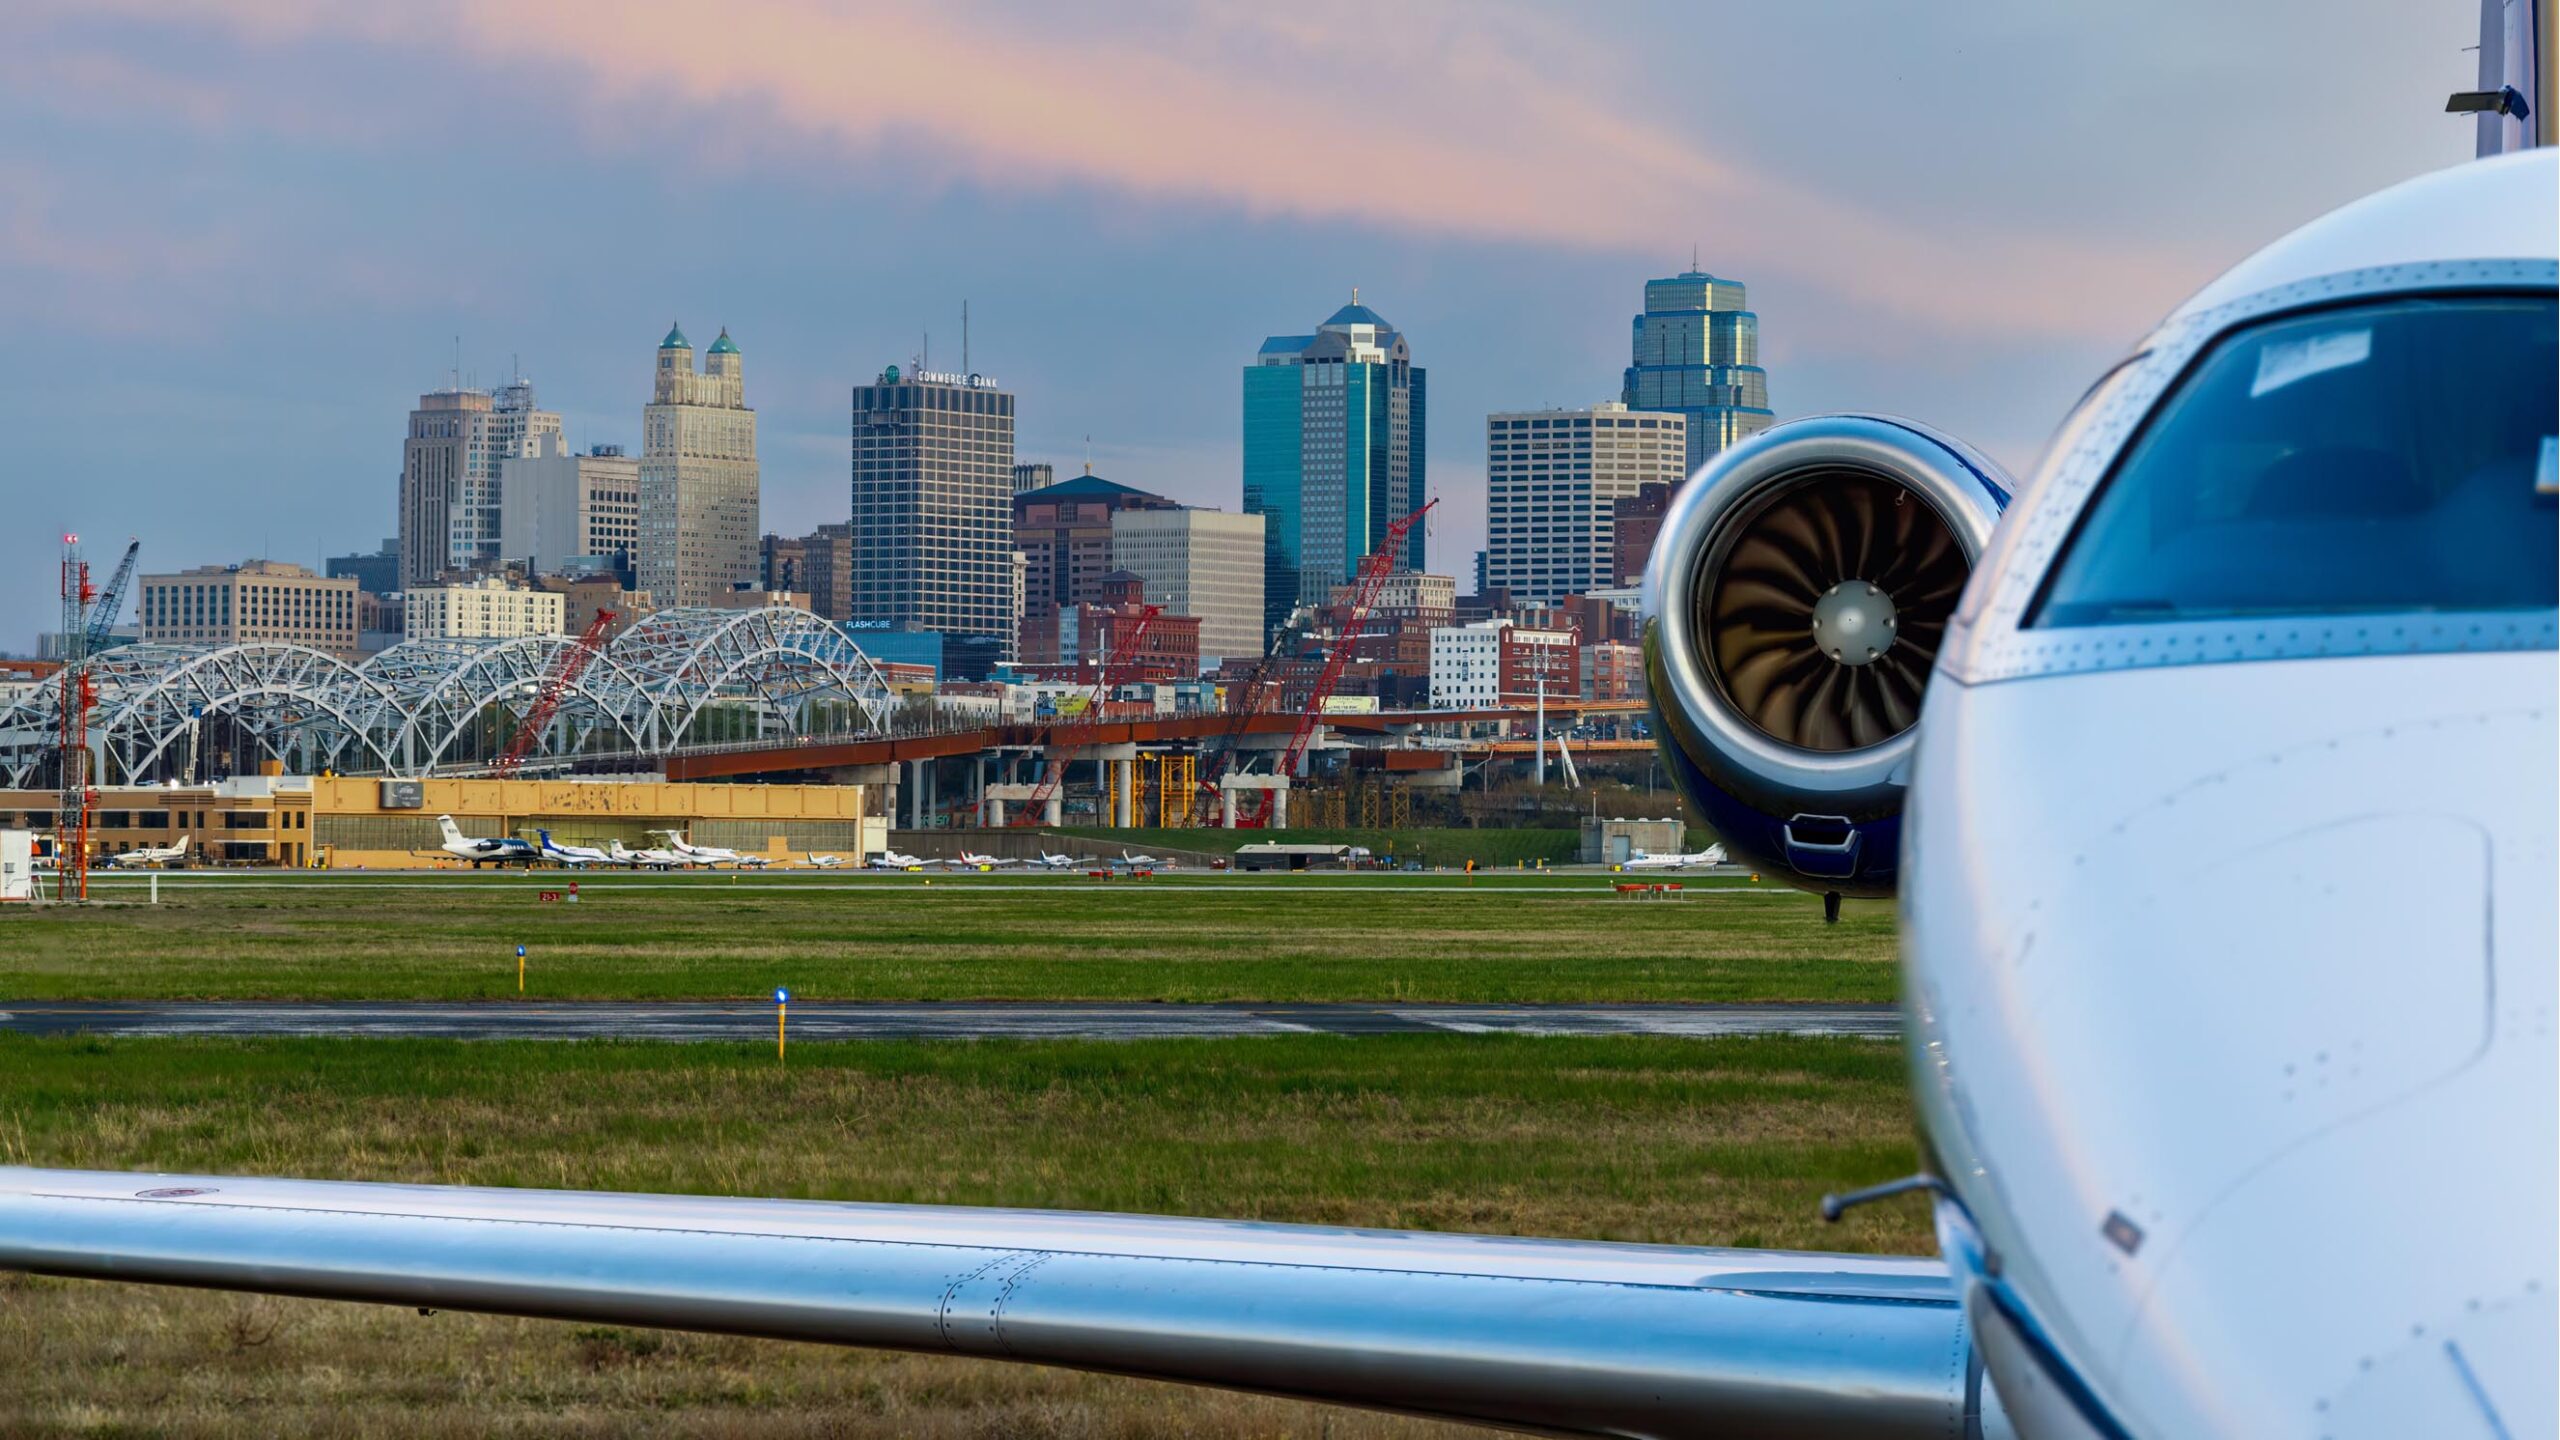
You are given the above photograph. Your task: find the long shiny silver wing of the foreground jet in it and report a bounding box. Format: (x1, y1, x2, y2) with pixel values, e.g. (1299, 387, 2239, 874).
(0, 1168, 2004, 1440)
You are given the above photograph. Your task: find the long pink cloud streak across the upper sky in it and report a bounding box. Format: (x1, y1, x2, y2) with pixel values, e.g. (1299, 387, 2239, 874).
(33, 0, 2209, 338)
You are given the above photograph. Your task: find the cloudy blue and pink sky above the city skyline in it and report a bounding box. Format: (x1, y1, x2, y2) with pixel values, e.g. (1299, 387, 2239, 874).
(0, 0, 2478, 640)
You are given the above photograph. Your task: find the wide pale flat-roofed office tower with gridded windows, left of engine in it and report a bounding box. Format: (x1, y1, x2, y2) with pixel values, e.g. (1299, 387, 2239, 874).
(1485, 402, 1690, 605)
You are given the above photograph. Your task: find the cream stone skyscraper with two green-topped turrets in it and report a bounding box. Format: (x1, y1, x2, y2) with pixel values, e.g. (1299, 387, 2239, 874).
(640, 325, 763, 605)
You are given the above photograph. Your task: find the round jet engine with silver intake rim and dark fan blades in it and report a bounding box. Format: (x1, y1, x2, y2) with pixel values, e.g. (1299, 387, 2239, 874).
(1644, 415, 2015, 897)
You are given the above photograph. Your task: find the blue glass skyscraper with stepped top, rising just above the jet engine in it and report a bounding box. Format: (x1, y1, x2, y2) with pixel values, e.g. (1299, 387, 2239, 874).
(1617, 266, 1777, 474)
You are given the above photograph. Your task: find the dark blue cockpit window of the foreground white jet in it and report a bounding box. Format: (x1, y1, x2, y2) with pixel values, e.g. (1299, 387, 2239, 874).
(2028, 295, 2560, 628)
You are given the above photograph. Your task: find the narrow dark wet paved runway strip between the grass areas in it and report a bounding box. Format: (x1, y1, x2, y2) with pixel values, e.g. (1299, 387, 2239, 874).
(0, 999, 1902, 1043)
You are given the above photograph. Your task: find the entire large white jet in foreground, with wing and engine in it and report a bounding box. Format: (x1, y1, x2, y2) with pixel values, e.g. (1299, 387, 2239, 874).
(0, 98, 2560, 1440)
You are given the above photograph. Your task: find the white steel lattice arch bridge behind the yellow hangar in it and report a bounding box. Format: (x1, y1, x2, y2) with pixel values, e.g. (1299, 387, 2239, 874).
(0, 607, 896, 787)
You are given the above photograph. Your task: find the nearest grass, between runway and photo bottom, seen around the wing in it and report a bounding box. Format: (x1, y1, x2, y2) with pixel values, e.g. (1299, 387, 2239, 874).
(0, 1035, 1928, 1440)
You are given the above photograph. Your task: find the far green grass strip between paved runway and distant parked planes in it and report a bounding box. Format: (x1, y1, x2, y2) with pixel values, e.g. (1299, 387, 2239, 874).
(0, 874, 1894, 1002)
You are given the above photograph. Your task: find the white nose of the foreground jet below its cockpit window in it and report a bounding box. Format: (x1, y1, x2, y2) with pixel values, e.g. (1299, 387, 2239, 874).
(1907, 653, 2560, 1437)
